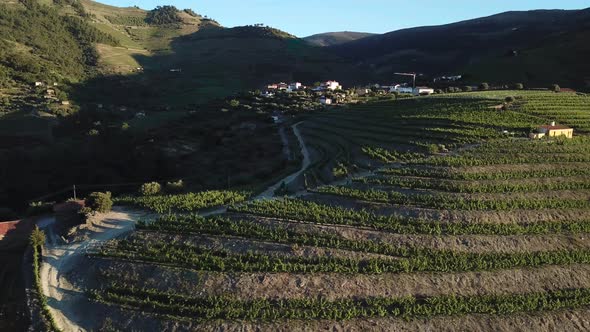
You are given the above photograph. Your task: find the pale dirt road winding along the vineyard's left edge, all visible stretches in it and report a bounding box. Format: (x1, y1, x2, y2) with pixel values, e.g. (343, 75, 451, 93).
(40, 122, 311, 332)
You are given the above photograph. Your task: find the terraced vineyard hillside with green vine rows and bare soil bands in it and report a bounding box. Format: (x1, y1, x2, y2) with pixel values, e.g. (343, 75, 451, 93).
(42, 91, 590, 331)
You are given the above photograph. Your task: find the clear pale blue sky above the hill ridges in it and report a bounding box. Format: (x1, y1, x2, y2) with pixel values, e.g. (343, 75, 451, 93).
(99, 0, 590, 37)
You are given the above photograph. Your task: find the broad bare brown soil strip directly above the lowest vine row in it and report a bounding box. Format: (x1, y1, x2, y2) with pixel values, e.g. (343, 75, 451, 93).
(101, 261, 590, 300)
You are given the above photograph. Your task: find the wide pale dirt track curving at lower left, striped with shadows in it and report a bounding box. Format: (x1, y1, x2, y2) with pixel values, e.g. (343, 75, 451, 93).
(40, 208, 150, 331)
